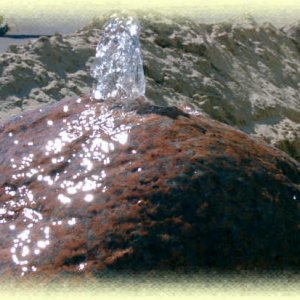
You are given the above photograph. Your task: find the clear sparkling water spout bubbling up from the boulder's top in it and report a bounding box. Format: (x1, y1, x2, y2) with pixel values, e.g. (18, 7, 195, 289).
(91, 15, 145, 100)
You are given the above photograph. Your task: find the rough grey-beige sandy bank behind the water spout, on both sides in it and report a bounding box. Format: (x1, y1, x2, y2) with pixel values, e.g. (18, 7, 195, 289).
(0, 15, 300, 160)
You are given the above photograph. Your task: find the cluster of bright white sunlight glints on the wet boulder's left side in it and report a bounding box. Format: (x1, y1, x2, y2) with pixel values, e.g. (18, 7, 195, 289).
(0, 94, 134, 276)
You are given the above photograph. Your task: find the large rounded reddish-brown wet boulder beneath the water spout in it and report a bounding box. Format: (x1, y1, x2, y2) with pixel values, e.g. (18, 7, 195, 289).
(0, 96, 300, 279)
